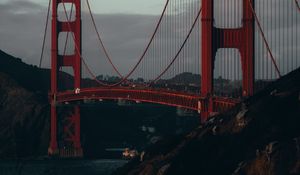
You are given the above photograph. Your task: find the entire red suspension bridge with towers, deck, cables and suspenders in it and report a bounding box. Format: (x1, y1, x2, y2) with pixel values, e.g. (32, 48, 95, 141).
(40, 0, 300, 157)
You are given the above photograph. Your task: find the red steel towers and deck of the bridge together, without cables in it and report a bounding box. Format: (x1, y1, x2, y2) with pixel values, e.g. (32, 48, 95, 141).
(48, 0, 244, 157)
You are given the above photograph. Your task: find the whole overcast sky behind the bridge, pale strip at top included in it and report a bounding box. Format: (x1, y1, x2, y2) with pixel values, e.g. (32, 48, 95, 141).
(0, 0, 300, 79)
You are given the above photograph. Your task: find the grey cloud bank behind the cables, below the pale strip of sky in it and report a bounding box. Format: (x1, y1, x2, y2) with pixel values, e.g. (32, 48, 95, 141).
(0, 0, 300, 78)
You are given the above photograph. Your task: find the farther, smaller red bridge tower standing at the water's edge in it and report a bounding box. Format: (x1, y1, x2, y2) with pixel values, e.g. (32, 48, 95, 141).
(48, 0, 82, 157)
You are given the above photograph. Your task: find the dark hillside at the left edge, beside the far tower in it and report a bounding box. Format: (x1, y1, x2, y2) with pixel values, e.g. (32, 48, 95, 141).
(0, 73, 49, 158)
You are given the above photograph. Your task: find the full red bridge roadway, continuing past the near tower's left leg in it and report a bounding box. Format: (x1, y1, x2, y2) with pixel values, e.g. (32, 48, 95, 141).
(55, 87, 240, 113)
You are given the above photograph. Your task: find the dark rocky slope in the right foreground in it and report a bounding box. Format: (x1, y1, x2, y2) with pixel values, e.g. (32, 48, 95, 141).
(115, 69, 300, 175)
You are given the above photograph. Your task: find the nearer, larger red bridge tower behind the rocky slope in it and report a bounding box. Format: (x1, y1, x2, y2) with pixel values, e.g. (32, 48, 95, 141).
(201, 0, 254, 121)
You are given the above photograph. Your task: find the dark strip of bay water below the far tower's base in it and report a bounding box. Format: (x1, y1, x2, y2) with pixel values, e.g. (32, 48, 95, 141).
(0, 159, 127, 175)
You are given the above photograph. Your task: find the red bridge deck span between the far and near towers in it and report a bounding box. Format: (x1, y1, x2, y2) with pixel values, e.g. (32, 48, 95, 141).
(57, 88, 202, 110)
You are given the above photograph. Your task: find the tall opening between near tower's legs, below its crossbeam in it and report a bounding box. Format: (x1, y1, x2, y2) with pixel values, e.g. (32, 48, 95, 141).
(213, 48, 242, 98)
